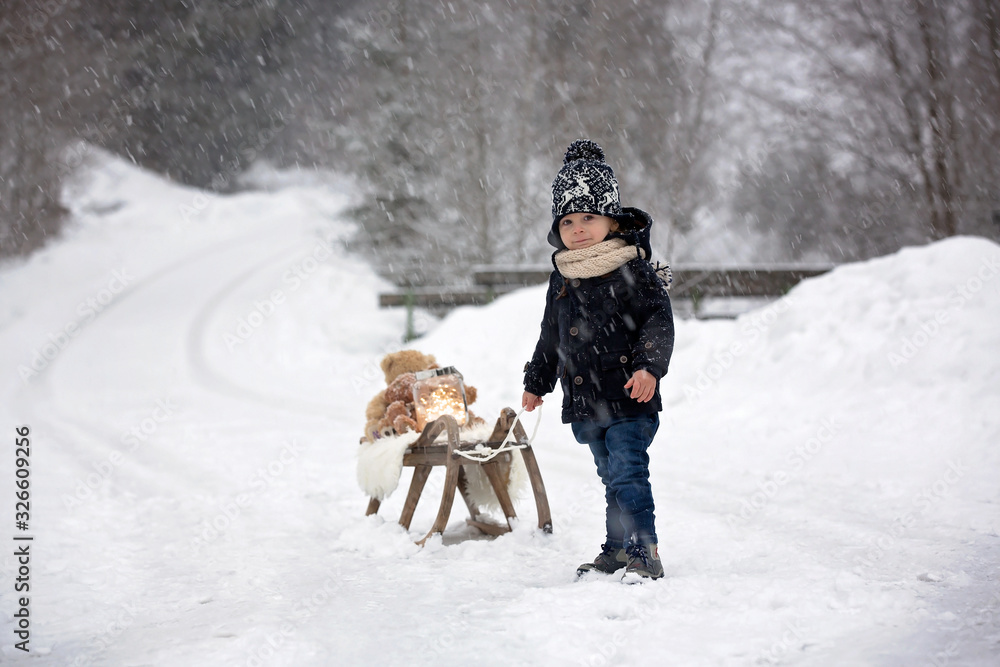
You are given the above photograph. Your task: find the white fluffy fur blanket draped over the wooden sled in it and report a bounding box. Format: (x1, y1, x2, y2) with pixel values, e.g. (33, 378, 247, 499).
(358, 424, 528, 511)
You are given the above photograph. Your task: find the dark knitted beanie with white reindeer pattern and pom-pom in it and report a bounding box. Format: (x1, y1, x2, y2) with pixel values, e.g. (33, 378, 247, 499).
(552, 139, 622, 223)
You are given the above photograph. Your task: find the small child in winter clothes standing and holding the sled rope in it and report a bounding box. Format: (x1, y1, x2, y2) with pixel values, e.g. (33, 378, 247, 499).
(521, 140, 674, 579)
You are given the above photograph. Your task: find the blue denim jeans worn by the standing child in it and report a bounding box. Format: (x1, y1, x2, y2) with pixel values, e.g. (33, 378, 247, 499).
(573, 412, 660, 549)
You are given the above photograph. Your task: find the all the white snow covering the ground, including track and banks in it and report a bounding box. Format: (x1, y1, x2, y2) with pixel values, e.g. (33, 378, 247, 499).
(0, 154, 1000, 667)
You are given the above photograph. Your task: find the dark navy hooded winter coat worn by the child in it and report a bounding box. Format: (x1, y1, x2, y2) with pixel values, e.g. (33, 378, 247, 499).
(524, 211, 674, 423)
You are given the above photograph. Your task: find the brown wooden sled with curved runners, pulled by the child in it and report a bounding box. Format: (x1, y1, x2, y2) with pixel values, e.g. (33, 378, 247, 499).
(365, 408, 552, 546)
